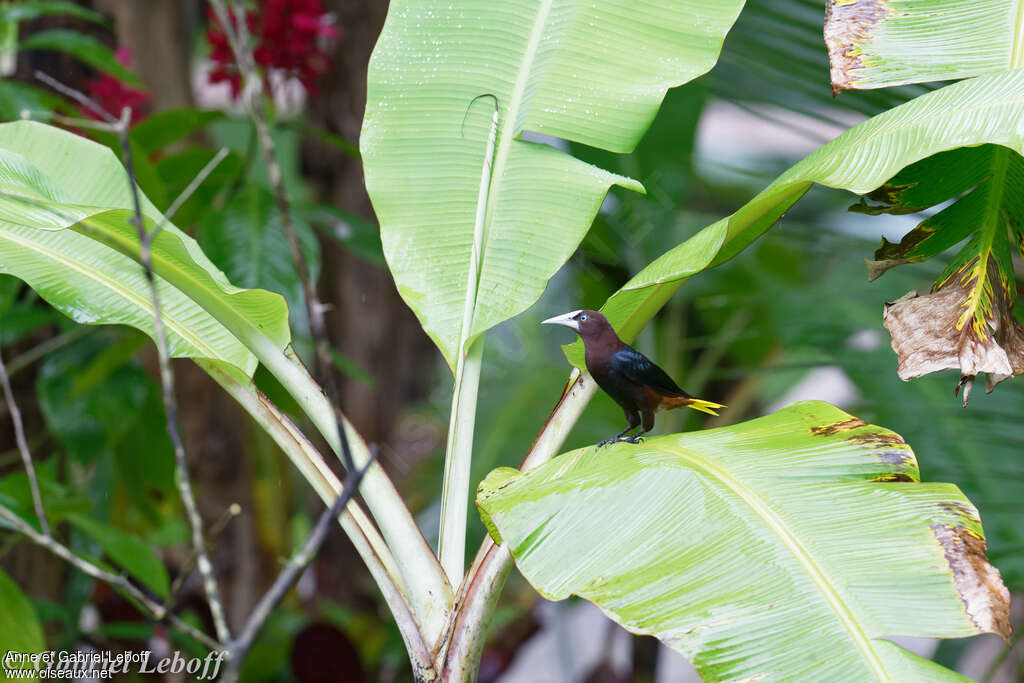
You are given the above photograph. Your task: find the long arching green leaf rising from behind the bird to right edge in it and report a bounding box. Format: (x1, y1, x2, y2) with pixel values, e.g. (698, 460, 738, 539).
(566, 70, 1024, 368)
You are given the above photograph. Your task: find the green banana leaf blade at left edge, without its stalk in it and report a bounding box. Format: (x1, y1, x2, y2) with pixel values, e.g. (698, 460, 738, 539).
(0, 121, 291, 375)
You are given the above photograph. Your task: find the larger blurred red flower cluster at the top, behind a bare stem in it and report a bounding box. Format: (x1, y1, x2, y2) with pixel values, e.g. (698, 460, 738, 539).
(206, 0, 341, 97)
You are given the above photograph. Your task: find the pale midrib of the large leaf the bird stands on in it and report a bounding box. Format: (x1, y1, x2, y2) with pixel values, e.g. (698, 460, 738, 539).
(659, 443, 892, 681)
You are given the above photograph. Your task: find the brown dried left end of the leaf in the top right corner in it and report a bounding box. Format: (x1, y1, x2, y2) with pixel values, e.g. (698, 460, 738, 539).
(824, 0, 889, 95)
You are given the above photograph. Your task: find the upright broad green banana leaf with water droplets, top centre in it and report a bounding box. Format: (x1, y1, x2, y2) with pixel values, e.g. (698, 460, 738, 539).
(359, 0, 743, 369)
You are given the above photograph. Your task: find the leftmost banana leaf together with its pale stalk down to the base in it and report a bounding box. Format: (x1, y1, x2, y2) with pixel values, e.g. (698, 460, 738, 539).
(0, 122, 451, 647)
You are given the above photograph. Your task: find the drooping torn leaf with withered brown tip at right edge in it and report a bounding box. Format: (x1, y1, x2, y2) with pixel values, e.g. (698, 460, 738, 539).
(853, 144, 1024, 404)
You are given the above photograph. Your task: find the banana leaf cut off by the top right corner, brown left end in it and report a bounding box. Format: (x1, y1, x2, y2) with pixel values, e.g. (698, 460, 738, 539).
(825, 0, 1024, 92)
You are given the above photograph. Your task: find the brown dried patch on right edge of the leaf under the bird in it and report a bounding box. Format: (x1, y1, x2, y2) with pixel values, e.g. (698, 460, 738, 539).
(931, 524, 1013, 640)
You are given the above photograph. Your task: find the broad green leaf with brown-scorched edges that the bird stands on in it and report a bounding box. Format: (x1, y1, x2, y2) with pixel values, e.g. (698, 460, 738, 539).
(477, 401, 1010, 681)
